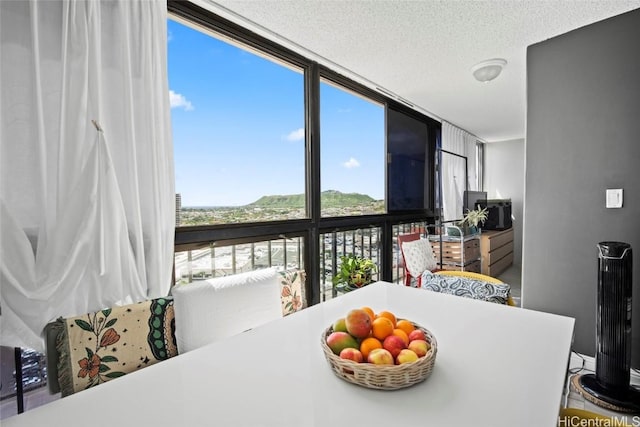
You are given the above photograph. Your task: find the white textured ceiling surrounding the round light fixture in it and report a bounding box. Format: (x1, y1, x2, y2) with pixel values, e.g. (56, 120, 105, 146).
(198, 0, 640, 142)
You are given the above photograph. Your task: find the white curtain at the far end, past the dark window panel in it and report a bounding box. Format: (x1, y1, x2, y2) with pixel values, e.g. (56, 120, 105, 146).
(441, 121, 478, 221)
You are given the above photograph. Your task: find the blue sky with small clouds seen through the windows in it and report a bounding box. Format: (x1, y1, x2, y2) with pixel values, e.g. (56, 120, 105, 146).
(168, 20, 384, 206)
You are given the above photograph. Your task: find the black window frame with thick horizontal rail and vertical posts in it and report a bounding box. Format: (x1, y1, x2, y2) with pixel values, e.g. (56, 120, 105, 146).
(167, 0, 441, 305)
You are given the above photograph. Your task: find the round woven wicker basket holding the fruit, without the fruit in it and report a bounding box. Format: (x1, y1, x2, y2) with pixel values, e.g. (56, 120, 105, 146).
(320, 323, 438, 390)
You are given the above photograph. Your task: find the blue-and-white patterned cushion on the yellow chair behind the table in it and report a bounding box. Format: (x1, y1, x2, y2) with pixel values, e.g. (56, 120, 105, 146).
(422, 271, 511, 304)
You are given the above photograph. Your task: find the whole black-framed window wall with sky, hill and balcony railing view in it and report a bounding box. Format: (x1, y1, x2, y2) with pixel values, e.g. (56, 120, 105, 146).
(168, 0, 440, 304)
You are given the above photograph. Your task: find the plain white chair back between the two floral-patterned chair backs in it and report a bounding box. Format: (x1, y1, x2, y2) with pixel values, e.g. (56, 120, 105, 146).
(171, 267, 282, 353)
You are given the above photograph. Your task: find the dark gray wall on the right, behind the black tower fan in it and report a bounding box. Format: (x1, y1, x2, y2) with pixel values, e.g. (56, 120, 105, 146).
(522, 9, 640, 368)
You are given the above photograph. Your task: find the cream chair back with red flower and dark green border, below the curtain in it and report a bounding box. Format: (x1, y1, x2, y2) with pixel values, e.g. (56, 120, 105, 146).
(48, 298, 178, 397)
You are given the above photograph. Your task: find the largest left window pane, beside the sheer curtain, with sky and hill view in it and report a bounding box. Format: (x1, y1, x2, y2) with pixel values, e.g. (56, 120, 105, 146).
(168, 20, 308, 226)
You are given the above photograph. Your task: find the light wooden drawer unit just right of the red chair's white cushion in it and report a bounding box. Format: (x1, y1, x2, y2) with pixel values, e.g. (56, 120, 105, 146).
(429, 234, 481, 273)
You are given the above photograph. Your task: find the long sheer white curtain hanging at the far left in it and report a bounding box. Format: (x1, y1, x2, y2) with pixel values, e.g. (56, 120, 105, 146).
(0, 0, 175, 351)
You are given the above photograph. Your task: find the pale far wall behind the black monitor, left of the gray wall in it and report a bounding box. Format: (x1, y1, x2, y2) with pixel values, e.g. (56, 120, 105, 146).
(483, 139, 524, 265)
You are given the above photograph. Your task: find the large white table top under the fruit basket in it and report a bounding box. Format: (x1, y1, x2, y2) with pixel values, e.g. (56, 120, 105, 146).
(2, 282, 574, 427)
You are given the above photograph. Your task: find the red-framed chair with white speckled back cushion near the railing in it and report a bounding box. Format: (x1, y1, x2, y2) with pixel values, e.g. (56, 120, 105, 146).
(398, 233, 438, 288)
